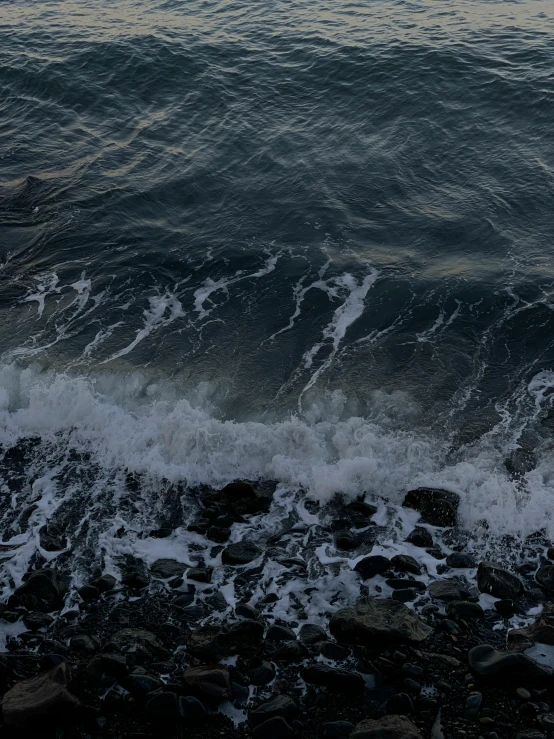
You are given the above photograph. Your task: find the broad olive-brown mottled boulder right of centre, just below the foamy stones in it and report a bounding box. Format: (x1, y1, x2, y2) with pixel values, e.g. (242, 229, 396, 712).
(329, 598, 432, 646)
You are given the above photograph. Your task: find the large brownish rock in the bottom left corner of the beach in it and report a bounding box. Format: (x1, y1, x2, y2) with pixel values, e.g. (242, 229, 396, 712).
(2, 663, 81, 729)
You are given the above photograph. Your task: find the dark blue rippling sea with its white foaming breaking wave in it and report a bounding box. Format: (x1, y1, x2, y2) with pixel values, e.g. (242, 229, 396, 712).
(0, 0, 554, 584)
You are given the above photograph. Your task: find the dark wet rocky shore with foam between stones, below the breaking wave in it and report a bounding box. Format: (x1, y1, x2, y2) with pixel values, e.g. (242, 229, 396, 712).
(0, 454, 554, 739)
